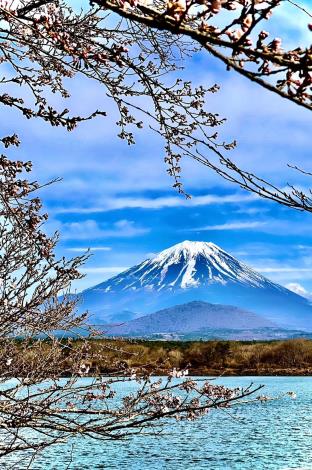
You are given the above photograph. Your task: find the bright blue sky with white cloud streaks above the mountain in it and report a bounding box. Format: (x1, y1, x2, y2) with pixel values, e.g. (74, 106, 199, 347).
(2, 0, 312, 292)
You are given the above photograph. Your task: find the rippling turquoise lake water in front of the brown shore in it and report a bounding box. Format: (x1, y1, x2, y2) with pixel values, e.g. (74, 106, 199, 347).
(7, 377, 312, 470)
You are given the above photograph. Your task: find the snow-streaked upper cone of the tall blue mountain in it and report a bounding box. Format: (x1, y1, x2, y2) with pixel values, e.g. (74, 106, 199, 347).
(92, 240, 271, 291)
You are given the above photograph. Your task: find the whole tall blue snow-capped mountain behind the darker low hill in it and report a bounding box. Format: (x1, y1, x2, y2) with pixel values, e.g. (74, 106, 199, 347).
(80, 241, 312, 332)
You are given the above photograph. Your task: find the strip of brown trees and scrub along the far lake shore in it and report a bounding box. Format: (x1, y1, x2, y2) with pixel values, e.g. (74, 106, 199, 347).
(36, 339, 312, 376)
